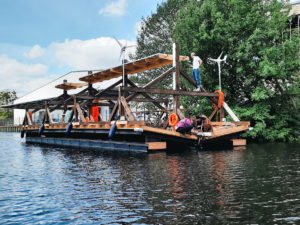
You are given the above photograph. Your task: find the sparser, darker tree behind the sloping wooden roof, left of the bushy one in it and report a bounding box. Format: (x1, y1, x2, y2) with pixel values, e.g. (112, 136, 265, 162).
(131, 0, 187, 109)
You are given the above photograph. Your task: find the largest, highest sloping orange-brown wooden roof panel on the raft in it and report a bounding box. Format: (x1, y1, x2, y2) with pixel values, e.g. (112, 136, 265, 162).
(79, 53, 189, 83)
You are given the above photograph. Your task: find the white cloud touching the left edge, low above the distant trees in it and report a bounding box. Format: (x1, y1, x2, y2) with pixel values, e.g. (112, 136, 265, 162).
(0, 55, 49, 95)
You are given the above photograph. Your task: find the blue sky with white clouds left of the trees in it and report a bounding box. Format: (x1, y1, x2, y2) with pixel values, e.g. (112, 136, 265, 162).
(0, 0, 164, 96)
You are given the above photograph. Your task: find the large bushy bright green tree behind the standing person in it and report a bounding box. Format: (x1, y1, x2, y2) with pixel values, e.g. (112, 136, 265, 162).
(173, 0, 300, 141)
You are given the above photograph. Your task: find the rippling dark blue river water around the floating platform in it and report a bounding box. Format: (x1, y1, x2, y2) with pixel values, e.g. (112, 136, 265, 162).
(0, 133, 300, 224)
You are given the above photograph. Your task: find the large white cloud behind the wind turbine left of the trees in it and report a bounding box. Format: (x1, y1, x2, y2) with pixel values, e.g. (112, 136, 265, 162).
(50, 37, 136, 69)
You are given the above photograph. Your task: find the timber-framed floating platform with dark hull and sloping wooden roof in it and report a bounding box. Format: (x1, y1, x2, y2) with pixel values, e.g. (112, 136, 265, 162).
(4, 44, 250, 152)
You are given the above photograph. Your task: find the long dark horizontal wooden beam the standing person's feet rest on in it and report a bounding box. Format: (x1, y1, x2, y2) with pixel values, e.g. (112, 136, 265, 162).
(122, 87, 219, 97)
